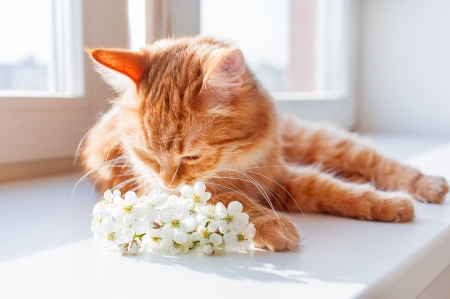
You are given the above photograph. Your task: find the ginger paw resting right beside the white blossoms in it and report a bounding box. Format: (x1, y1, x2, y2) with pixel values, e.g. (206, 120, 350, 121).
(252, 215, 300, 251)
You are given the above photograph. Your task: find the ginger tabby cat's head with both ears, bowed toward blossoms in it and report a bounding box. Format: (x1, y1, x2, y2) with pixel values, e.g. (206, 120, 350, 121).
(89, 36, 276, 190)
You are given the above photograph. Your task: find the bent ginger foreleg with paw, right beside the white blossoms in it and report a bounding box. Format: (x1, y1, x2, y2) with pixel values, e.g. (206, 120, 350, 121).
(211, 192, 300, 251)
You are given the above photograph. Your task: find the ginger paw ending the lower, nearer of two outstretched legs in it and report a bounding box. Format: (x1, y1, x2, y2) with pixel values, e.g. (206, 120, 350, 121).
(371, 192, 414, 222)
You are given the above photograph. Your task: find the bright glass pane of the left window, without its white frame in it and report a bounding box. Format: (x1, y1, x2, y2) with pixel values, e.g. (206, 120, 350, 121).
(0, 0, 51, 91)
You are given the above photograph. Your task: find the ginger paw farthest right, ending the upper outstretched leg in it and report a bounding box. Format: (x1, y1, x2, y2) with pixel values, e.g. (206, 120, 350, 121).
(410, 176, 449, 203)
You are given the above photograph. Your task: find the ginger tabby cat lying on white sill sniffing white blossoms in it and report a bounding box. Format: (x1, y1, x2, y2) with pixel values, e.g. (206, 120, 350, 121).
(82, 36, 449, 251)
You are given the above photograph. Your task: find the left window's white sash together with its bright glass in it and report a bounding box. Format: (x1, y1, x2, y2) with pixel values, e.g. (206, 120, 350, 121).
(0, 0, 83, 97)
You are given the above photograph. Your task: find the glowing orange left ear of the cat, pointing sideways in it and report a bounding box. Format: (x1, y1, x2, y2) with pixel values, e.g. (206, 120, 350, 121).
(87, 48, 146, 85)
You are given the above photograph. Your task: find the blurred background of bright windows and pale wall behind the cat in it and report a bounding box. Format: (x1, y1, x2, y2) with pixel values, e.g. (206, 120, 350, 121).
(0, 0, 450, 180)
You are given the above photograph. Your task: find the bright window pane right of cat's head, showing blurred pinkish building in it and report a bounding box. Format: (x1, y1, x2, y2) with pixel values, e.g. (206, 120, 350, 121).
(200, 0, 316, 92)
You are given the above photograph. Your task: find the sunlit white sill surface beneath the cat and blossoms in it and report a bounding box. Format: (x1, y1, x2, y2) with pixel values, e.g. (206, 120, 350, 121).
(0, 137, 450, 298)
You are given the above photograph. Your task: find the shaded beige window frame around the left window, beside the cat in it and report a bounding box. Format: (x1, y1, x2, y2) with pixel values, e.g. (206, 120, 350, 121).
(0, 0, 128, 169)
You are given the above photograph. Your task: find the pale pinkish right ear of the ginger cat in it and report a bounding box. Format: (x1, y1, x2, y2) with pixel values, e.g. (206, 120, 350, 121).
(203, 49, 245, 94)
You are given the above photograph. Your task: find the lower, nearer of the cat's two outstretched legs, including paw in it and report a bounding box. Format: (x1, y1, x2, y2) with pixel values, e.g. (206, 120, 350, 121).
(285, 167, 414, 222)
